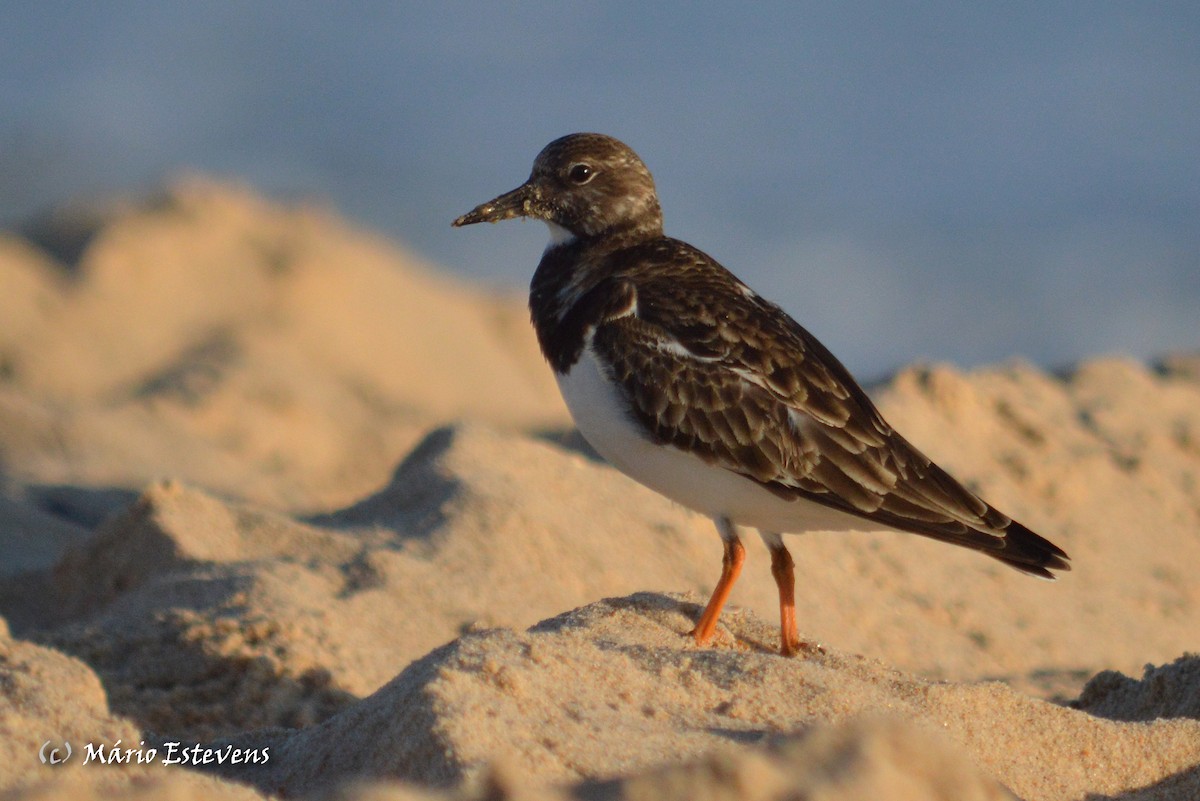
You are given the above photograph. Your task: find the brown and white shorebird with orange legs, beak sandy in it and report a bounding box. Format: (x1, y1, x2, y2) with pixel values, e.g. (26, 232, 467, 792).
(452, 133, 1070, 656)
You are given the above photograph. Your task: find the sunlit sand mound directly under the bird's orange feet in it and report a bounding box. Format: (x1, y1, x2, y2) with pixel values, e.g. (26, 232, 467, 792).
(216, 594, 1200, 799)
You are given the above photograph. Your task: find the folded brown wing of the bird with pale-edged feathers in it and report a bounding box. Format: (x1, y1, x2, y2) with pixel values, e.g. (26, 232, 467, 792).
(592, 256, 1056, 561)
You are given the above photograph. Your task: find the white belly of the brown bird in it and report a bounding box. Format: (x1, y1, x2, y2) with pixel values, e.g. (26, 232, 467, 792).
(556, 348, 882, 532)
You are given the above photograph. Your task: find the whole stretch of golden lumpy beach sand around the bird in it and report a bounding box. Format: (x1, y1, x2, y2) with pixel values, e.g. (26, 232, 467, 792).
(0, 176, 1200, 800)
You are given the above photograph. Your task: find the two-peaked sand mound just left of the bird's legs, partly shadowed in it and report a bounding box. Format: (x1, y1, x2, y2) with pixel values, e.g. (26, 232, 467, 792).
(23, 426, 713, 736)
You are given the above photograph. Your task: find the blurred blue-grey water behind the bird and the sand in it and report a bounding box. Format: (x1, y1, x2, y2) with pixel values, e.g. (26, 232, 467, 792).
(0, 1, 1200, 378)
